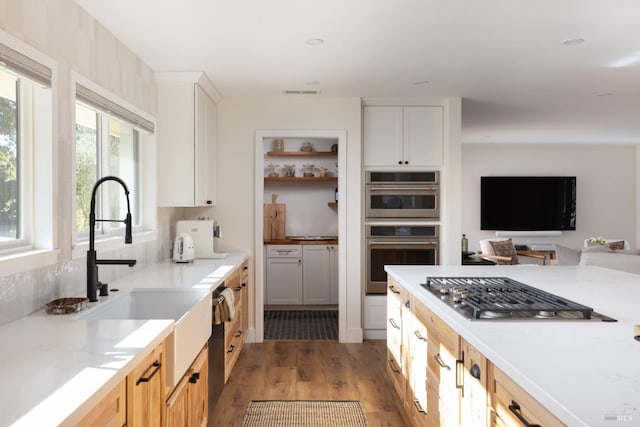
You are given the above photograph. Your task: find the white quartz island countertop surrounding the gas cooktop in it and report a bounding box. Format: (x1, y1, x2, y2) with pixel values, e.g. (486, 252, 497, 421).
(386, 265, 640, 426)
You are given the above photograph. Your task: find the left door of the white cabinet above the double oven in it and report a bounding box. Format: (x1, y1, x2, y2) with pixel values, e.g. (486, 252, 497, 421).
(364, 107, 403, 167)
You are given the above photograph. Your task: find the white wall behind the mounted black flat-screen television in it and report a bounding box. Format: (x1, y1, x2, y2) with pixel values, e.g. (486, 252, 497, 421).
(462, 144, 637, 251)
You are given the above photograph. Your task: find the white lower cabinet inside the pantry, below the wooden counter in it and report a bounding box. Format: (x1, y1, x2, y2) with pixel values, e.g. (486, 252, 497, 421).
(265, 245, 338, 305)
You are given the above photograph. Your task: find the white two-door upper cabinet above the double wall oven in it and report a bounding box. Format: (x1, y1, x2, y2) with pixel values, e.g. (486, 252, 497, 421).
(364, 107, 443, 168)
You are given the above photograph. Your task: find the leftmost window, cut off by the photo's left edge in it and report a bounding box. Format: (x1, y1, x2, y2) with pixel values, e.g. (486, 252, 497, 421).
(0, 44, 52, 253)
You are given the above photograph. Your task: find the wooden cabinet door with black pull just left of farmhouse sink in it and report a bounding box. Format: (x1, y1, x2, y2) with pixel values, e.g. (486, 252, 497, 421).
(127, 342, 165, 427)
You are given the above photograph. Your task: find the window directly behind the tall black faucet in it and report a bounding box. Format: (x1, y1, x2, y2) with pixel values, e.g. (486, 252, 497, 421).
(75, 102, 140, 237)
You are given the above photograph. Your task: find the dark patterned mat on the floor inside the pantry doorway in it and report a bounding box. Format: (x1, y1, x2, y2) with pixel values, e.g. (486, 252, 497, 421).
(264, 310, 338, 340)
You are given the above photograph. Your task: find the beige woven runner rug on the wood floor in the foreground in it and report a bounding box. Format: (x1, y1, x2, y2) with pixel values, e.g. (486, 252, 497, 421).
(242, 400, 367, 427)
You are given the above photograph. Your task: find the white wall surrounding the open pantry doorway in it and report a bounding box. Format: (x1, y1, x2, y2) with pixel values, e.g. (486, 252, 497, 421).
(185, 95, 362, 339)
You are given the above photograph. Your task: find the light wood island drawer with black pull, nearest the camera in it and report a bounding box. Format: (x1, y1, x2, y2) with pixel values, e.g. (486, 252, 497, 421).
(489, 364, 564, 427)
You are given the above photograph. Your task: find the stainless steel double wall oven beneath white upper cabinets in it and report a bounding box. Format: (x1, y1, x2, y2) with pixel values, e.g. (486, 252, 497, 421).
(365, 171, 440, 295)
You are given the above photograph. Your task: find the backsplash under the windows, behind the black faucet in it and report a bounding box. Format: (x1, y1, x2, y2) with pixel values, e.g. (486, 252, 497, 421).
(0, 241, 157, 325)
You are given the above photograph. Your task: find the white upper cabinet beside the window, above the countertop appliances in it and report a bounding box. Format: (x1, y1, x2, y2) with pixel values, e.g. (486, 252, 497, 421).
(156, 73, 217, 207)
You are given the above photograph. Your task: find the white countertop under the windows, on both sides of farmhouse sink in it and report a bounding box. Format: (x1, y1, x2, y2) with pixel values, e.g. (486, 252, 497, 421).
(0, 253, 246, 426)
